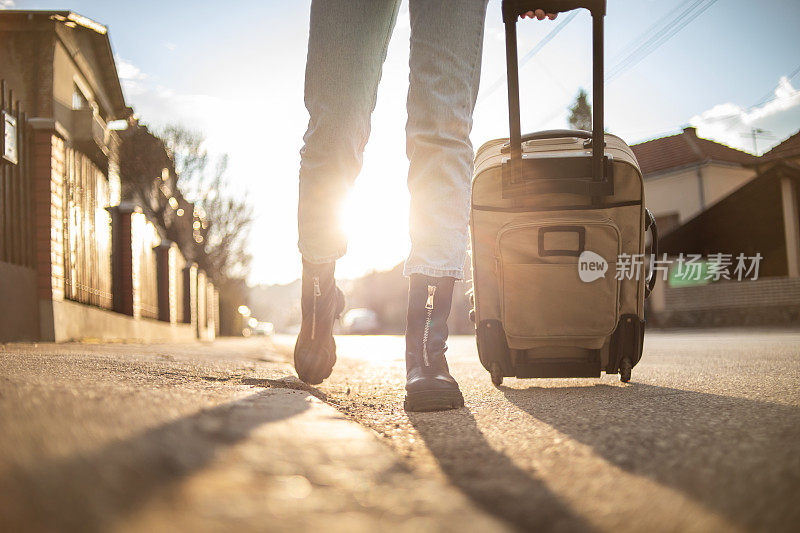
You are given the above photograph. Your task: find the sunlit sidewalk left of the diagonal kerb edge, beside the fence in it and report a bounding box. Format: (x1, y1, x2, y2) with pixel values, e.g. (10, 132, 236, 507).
(0, 340, 505, 532)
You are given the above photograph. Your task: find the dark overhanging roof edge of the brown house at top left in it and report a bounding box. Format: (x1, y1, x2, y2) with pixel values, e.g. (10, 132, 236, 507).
(0, 9, 131, 119)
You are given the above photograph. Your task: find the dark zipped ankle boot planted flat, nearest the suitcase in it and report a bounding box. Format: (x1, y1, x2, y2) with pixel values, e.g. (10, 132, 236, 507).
(404, 274, 464, 411)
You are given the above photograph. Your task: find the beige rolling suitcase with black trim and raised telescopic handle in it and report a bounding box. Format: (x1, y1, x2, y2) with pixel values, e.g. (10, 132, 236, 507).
(470, 0, 658, 385)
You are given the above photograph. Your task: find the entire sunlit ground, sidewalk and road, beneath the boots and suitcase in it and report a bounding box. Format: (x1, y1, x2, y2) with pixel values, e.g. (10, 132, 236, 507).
(0, 331, 800, 532)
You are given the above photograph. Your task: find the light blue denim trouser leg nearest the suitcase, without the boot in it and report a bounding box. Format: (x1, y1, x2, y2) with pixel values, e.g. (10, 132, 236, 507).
(405, 0, 486, 279)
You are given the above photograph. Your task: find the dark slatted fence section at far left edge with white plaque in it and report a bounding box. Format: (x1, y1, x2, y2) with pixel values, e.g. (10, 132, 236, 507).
(0, 81, 35, 267)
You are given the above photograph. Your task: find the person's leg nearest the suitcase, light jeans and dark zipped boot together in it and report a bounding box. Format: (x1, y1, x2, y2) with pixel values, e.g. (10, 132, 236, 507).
(405, 0, 487, 411)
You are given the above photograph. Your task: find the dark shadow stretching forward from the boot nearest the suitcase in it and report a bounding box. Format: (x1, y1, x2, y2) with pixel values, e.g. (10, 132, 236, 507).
(408, 409, 592, 531)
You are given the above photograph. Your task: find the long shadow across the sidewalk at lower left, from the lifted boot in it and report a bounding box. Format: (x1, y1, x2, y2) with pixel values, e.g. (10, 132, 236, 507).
(0, 390, 308, 532)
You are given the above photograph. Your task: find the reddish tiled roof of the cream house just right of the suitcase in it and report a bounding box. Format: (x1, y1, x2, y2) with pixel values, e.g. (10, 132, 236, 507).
(631, 127, 758, 176)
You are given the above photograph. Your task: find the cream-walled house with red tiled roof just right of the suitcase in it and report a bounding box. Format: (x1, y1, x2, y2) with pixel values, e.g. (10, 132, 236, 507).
(631, 127, 758, 234)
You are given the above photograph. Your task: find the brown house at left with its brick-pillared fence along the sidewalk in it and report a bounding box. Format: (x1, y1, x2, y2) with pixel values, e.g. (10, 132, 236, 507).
(0, 10, 216, 341)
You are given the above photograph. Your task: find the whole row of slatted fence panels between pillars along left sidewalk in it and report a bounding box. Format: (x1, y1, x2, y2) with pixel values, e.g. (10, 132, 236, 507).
(0, 80, 218, 338)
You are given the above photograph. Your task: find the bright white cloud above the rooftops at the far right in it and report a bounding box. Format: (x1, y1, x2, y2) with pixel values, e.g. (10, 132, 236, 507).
(689, 76, 800, 154)
